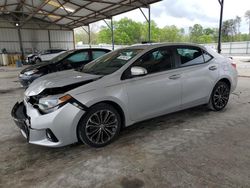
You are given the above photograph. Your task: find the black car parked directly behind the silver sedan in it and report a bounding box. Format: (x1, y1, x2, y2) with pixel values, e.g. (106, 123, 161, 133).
(19, 48, 110, 87)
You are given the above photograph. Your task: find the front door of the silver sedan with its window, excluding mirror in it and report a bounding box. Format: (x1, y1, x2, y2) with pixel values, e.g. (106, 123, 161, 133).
(124, 47, 181, 122)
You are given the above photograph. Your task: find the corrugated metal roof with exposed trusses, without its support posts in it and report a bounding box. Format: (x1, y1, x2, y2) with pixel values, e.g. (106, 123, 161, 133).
(0, 0, 161, 29)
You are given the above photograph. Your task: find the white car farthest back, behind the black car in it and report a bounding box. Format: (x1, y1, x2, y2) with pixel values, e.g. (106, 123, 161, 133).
(25, 49, 66, 64)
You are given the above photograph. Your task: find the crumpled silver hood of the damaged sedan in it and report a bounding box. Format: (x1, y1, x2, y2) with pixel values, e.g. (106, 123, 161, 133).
(24, 70, 101, 96)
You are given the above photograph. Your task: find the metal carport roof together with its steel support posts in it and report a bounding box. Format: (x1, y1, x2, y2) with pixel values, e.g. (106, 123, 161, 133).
(0, 0, 160, 58)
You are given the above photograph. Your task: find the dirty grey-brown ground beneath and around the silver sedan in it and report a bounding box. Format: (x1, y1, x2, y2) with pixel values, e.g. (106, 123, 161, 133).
(0, 65, 250, 188)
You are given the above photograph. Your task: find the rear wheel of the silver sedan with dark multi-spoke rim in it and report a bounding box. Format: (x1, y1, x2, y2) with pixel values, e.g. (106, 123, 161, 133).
(208, 81, 230, 111)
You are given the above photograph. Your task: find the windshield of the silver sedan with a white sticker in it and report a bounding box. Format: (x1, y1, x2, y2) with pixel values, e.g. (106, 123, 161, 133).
(82, 49, 142, 75)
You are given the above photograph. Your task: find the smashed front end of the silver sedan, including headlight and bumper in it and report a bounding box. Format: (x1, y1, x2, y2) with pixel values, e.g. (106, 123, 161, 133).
(11, 72, 96, 147)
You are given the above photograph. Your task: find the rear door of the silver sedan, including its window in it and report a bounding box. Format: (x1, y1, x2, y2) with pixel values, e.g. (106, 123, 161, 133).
(175, 46, 218, 108)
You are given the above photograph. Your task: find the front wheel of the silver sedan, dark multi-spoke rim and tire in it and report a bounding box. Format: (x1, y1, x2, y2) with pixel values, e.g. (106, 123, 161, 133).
(77, 103, 121, 148)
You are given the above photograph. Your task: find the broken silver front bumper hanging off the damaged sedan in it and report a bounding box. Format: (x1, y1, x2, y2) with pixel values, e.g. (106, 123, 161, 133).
(11, 100, 85, 147)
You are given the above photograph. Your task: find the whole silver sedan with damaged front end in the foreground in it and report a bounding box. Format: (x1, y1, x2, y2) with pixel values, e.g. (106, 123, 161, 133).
(12, 43, 237, 147)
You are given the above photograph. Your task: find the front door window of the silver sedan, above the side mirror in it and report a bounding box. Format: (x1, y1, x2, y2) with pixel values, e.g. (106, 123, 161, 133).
(132, 48, 174, 74)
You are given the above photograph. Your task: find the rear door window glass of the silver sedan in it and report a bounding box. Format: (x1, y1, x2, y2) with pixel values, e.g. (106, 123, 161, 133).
(177, 47, 204, 67)
